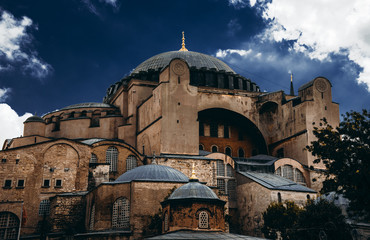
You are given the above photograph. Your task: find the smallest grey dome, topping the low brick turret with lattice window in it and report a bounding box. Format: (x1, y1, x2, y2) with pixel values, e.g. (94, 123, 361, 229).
(168, 179, 220, 200)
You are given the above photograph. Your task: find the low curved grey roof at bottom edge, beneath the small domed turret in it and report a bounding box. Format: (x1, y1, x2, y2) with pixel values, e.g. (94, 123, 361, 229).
(146, 230, 265, 240)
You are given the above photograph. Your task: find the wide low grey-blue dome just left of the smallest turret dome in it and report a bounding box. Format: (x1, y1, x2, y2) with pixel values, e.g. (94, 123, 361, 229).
(114, 164, 189, 183)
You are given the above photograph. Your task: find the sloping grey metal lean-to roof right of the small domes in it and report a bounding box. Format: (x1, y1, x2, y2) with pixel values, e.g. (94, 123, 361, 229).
(237, 171, 316, 193)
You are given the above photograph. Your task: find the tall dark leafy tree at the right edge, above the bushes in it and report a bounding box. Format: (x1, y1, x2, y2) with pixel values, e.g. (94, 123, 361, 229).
(306, 110, 370, 220)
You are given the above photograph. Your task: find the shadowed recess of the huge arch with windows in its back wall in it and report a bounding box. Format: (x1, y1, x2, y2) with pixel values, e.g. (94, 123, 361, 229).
(198, 108, 268, 157)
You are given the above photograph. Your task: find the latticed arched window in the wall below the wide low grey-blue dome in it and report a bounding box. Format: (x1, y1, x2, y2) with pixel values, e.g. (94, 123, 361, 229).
(112, 197, 130, 228)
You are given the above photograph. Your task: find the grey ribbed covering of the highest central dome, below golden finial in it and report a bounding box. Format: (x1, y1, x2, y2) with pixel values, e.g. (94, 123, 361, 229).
(131, 51, 235, 74)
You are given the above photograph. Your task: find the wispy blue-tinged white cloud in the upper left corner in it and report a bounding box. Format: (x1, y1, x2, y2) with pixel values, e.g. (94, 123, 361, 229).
(0, 9, 52, 78)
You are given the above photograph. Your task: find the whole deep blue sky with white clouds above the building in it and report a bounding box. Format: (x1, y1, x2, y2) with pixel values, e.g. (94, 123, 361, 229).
(0, 0, 370, 145)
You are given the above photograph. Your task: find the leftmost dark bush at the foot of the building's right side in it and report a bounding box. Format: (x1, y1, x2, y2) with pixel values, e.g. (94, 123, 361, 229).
(262, 201, 302, 239)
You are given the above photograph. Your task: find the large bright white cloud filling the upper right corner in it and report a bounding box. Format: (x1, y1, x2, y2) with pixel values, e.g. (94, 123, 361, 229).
(257, 0, 370, 91)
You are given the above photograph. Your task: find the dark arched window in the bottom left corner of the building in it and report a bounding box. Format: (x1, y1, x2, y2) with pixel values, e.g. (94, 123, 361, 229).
(0, 212, 19, 240)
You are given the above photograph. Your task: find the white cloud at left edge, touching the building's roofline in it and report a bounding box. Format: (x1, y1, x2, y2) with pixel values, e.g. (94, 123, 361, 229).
(0, 103, 32, 148)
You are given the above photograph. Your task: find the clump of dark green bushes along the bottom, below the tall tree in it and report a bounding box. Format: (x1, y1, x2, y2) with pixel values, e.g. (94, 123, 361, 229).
(262, 200, 351, 240)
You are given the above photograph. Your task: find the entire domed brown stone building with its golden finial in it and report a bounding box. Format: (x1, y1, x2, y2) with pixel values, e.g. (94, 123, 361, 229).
(0, 34, 339, 239)
